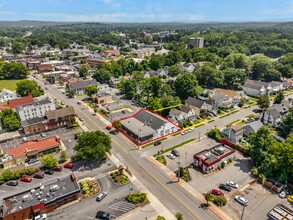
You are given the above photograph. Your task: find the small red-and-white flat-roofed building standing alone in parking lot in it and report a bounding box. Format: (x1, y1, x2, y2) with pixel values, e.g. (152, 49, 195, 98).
(193, 144, 235, 173)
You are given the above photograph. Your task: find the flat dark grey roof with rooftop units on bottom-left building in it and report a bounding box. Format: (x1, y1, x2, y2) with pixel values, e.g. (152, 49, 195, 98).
(3, 174, 80, 217)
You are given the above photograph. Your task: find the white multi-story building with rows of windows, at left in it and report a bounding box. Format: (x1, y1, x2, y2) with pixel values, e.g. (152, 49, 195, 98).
(16, 99, 56, 121)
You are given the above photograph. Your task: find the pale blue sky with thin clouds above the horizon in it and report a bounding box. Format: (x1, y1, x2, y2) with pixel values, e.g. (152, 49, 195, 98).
(0, 0, 293, 22)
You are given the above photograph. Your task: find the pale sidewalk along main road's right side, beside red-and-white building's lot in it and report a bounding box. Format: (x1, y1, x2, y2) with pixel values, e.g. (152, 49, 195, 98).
(149, 157, 233, 220)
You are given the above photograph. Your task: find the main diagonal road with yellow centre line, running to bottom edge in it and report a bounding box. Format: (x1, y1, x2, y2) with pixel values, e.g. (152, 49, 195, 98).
(32, 75, 219, 219)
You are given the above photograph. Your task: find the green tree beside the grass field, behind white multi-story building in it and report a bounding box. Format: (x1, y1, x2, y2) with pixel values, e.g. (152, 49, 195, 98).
(16, 80, 44, 97)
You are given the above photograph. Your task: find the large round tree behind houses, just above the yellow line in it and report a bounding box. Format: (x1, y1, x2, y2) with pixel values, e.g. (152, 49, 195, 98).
(174, 73, 202, 100)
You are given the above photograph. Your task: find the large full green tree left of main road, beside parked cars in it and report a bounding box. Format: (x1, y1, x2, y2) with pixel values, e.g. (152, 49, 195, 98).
(74, 131, 111, 160)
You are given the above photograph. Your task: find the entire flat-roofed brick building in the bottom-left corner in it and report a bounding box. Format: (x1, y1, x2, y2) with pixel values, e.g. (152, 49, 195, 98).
(2, 174, 81, 220)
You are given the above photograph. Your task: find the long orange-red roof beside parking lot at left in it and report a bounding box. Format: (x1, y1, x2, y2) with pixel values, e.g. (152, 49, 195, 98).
(6, 136, 59, 158)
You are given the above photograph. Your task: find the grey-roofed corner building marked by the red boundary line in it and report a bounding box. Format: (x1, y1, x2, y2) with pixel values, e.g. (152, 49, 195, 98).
(120, 109, 180, 144)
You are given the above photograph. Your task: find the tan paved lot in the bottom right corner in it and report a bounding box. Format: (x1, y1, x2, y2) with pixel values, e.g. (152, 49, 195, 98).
(224, 183, 292, 220)
